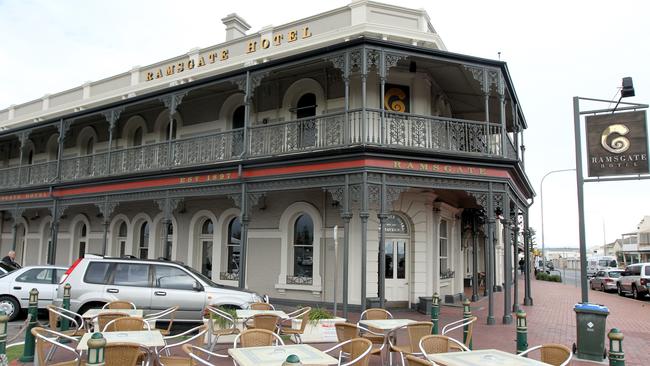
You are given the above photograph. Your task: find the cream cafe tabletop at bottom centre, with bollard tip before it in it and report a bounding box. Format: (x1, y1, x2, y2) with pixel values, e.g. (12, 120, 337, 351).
(228, 344, 339, 366)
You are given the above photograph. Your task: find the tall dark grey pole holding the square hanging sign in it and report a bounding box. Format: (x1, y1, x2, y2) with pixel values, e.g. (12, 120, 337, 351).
(573, 97, 589, 303)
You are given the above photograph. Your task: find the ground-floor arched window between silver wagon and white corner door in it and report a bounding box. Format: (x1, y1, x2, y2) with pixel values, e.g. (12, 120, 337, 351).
(293, 214, 314, 278)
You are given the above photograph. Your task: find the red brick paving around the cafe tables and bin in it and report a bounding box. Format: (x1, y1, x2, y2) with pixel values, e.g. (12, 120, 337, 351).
(10, 280, 650, 366)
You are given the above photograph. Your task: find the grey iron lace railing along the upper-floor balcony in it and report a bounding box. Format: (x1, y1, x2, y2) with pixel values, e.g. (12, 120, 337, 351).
(0, 109, 517, 188)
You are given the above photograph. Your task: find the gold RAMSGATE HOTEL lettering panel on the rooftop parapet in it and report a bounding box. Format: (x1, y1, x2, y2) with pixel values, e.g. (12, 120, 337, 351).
(145, 26, 311, 81)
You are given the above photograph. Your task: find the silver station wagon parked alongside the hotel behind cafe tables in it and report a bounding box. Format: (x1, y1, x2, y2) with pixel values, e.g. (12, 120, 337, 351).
(55, 256, 262, 321)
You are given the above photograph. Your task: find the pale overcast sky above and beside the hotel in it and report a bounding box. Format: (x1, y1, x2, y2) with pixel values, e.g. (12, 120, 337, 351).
(0, 0, 650, 247)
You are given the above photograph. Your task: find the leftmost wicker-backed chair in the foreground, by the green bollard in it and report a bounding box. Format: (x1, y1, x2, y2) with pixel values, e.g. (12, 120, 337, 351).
(32, 327, 85, 366)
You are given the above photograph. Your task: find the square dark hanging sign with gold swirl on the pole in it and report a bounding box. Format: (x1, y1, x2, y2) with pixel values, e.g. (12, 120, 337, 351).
(585, 111, 649, 177)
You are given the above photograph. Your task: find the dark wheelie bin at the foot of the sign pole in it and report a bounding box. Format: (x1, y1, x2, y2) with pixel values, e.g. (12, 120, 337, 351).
(573, 303, 609, 362)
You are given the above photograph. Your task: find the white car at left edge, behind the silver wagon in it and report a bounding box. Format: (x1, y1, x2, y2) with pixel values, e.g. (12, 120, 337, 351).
(0, 266, 66, 320)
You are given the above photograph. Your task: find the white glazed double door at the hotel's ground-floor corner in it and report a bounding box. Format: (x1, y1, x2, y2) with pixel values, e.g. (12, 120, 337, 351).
(385, 238, 409, 301)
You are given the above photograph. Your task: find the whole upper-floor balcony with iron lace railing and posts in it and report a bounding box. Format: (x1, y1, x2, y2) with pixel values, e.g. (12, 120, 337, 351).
(0, 41, 525, 190)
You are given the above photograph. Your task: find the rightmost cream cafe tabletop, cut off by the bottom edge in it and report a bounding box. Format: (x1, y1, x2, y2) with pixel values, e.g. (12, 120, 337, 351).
(427, 349, 548, 366)
